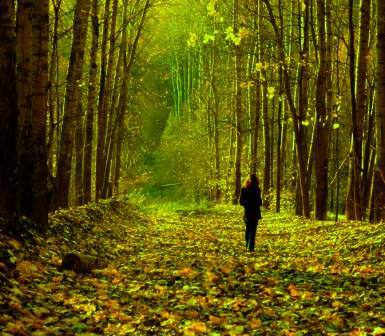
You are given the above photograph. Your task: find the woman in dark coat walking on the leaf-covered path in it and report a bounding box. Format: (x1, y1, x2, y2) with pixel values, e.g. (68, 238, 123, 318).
(239, 174, 262, 251)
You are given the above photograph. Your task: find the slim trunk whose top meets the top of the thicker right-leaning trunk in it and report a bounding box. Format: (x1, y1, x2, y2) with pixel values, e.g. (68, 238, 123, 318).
(83, 0, 99, 203)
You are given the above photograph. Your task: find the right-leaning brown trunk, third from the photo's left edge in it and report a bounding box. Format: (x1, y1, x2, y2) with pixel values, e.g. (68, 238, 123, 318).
(55, 0, 90, 207)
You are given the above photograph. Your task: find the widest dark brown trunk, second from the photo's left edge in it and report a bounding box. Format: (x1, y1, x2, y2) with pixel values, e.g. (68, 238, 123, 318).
(17, 0, 49, 228)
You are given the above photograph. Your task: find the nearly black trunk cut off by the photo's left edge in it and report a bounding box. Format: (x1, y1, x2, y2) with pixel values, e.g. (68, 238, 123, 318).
(0, 0, 18, 232)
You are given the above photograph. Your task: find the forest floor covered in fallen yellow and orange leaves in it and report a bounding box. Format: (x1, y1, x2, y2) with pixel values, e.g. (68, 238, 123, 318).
(0, 200, 385, 336)
